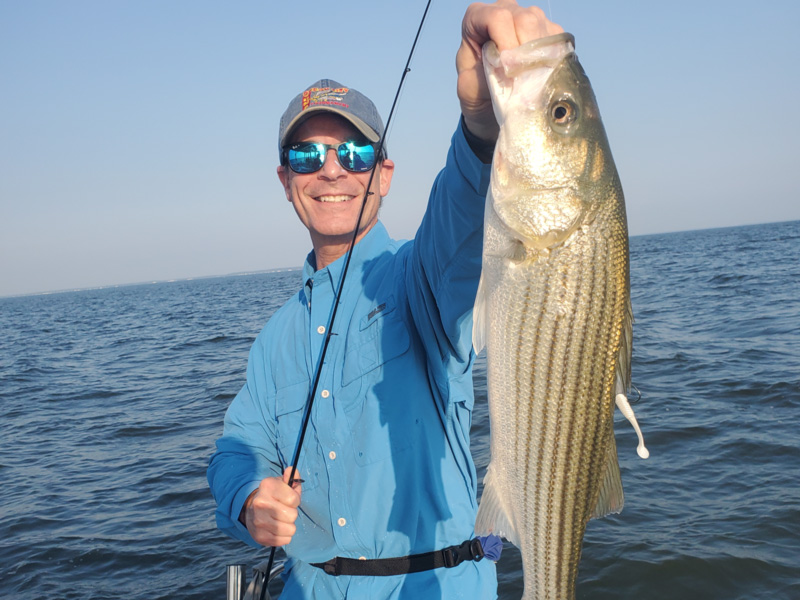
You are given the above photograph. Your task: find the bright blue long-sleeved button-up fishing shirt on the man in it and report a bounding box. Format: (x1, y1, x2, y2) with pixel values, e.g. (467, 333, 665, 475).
(208, 119, 497, 600)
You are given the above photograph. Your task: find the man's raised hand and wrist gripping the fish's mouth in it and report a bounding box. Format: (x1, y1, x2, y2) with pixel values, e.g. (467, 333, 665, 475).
(456, 0, 564, 142)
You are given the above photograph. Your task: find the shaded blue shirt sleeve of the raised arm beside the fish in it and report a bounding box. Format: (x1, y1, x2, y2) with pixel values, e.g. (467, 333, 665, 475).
(407, 120, 491, 375)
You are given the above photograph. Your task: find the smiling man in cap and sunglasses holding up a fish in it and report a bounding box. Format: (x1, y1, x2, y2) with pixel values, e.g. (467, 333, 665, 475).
(208, 0, 561, 600)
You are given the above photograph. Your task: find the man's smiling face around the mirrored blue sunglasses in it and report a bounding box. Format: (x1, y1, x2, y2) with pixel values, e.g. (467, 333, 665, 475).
(278, 113, 394, 256)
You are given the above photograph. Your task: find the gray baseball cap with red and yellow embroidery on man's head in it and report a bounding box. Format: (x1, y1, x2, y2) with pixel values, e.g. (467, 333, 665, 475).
(278, 79, 385, 152)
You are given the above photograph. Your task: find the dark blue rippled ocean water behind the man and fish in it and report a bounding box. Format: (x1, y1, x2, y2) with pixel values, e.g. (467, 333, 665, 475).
(0, 221, 800, 600)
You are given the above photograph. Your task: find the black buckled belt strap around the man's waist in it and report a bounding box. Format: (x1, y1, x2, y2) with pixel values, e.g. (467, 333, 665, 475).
(310, 538, 483, 576)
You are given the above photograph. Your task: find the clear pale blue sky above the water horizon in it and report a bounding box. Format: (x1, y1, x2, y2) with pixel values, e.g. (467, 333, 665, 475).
(0, 0, 800, 296)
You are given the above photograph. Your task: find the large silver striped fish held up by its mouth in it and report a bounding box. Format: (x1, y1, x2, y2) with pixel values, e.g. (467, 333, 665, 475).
(473, 33, 649, 600)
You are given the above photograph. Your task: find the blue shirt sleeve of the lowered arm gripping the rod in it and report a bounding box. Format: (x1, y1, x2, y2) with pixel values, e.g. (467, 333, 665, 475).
(207, 334, 282, 547)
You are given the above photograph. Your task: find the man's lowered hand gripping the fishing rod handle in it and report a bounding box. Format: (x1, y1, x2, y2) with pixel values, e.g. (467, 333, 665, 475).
(239, 467, 302, 546)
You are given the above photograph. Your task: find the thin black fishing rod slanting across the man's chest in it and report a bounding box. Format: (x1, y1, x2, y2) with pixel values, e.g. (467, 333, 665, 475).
(261, 0, 432, 600)
